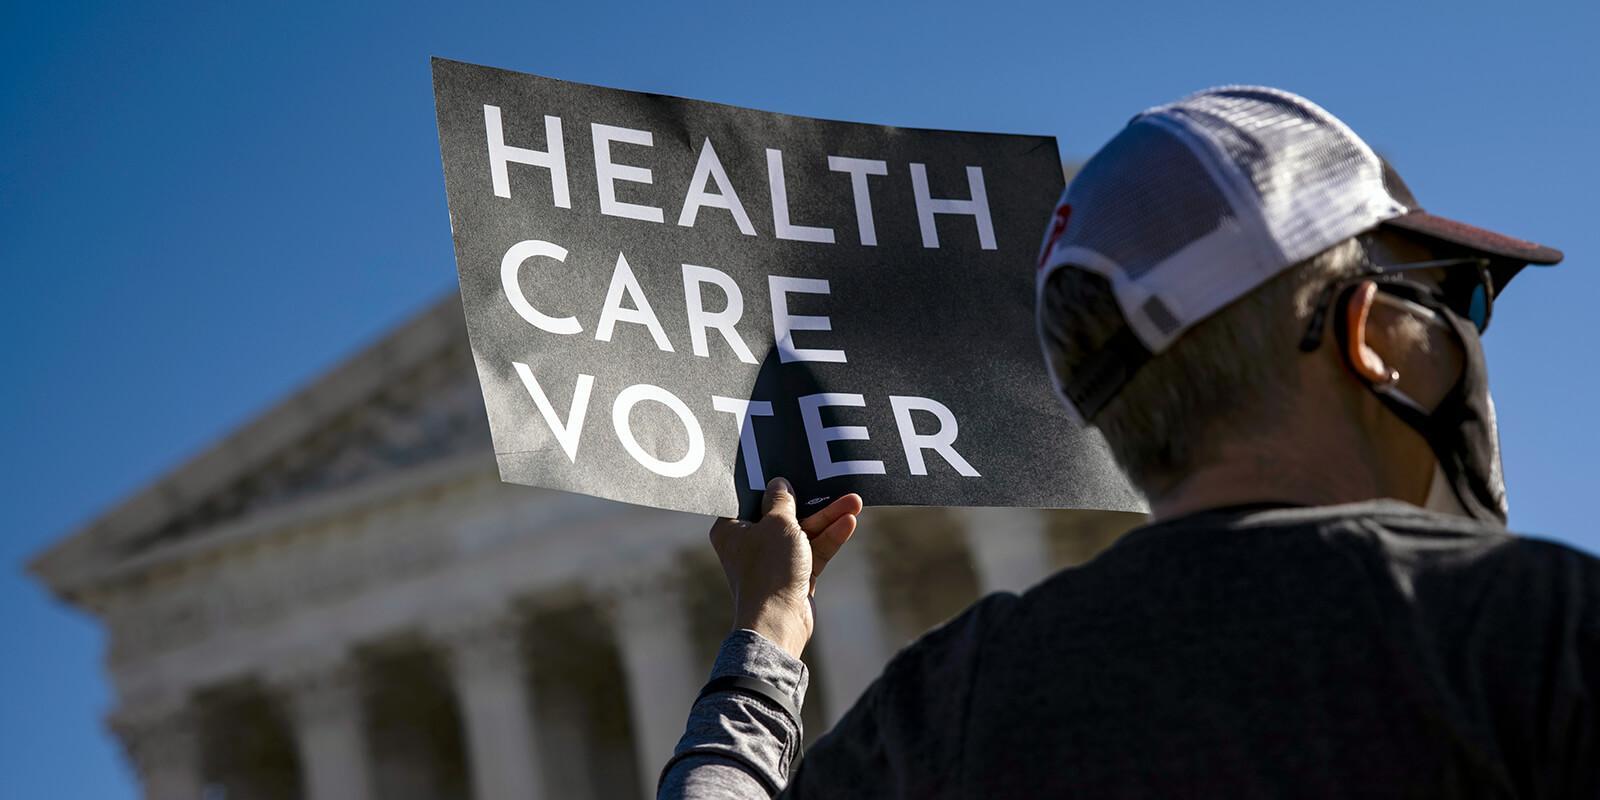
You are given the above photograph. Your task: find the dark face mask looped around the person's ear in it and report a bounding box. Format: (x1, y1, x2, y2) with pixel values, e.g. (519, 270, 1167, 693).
(1301, 280, 1507, 526)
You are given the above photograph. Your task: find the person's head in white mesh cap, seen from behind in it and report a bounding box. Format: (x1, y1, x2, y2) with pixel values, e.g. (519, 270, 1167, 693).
(1038, 86, 1560, 518)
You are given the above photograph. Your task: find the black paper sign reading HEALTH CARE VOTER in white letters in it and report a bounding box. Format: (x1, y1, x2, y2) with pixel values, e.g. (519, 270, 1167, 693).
(434, 59, 1141, 517)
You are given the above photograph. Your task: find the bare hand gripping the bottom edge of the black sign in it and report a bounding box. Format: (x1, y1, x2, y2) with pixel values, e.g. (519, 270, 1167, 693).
(710, 478, 862, 658)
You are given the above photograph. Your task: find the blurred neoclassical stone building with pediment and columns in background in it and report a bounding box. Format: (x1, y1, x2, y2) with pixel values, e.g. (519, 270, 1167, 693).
(32, 298, 1139, 800)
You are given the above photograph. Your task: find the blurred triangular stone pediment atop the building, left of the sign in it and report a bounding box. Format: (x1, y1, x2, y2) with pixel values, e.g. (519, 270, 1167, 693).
(30, 293, 491, 600)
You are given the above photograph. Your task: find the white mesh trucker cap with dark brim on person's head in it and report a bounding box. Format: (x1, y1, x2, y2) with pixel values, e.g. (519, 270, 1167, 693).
(1037, 86, 1562, 421)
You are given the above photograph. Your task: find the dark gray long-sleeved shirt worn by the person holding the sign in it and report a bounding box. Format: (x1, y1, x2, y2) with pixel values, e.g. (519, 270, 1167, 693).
(662, 501, 1600, 800)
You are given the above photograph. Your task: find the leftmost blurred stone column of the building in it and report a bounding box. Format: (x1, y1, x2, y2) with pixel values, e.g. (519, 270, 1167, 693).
(110, 704, 205, 800)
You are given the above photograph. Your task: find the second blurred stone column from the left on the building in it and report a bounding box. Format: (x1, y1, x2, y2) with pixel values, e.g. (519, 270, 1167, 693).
(275, 659, 373, 800)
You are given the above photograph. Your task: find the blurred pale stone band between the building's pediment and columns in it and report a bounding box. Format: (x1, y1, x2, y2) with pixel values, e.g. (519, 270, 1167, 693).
(110, 502, 706, 696)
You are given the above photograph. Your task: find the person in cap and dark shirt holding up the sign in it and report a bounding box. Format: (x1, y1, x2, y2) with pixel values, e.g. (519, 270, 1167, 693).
(661, 86, 1600, 798)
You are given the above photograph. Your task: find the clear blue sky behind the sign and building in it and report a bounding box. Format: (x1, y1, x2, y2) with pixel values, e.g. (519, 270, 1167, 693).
(0, 0, 1600, 798)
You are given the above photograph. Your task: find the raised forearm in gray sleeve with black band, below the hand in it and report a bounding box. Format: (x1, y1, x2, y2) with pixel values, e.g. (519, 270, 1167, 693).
(658, 630, 810, 800)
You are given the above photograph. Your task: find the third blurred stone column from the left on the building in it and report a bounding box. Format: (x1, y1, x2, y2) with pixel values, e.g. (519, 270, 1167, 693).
(438, 613, 544, 800)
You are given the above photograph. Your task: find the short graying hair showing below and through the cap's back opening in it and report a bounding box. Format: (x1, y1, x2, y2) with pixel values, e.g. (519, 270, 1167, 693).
(1040, 238, 1365, 488)
